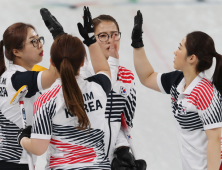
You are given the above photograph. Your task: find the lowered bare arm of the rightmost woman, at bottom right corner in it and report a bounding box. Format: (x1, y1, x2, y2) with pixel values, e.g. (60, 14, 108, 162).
(205, 128, 221, 170)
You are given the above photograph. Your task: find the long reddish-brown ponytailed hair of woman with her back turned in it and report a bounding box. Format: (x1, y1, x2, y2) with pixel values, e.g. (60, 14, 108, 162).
(50, 34, 90, 129)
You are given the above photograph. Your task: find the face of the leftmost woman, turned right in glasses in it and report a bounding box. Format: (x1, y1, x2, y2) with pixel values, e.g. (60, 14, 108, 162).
(20, 28, 43, 66)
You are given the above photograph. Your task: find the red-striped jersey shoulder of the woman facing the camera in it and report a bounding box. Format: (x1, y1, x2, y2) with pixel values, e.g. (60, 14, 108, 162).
(118, 66, 134, 83)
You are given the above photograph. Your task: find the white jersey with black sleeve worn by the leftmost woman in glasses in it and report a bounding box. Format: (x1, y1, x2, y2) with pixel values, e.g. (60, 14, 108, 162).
(0, 64, 42, 164)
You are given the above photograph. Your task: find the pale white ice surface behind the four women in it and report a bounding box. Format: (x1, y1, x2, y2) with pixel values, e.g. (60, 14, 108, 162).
(0, 0, 222, 170)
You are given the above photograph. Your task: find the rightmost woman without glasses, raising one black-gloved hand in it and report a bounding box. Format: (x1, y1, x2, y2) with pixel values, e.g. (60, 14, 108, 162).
(131, 11, 222, 170)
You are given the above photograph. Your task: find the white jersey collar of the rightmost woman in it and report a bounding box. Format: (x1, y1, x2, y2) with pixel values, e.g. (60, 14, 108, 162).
(177, 72, 208, 95)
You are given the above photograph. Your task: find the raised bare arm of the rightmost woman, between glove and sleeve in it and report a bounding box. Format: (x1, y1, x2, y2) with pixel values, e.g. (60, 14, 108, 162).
(133, 47, 160, 92)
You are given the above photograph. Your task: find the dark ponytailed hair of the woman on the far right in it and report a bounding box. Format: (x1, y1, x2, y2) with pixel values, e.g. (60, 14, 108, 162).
(185, 31, 222, 94)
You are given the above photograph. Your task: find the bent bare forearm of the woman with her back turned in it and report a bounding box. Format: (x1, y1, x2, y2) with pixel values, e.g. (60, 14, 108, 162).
(20, 137, 50, 156)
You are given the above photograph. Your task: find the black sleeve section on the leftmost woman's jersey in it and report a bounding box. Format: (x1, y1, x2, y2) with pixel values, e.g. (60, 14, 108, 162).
(11, 71, 39, 98)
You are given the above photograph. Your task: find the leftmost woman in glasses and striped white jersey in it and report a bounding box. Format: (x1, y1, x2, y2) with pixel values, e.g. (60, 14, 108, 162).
(0, 23, 58, 170)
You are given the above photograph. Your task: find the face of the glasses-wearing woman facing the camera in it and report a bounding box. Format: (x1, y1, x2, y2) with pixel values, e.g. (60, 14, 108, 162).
(95, 21, 120, 59)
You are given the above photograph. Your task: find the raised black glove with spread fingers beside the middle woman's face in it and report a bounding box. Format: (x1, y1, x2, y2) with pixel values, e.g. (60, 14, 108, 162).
(77, 6, 96, 47)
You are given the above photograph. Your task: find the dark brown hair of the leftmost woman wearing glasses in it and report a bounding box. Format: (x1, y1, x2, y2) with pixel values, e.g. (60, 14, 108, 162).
(0, 22, 35, 76)
